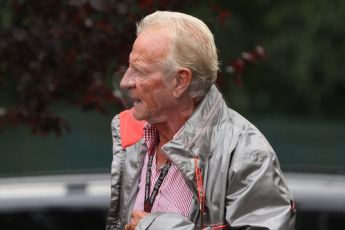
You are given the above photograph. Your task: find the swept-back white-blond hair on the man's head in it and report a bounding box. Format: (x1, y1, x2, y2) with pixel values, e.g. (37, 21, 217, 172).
(137, 11, 219, 100)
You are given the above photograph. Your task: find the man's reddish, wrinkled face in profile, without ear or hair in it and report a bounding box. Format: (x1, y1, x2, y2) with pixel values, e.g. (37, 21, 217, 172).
(120, 29, 176, 124)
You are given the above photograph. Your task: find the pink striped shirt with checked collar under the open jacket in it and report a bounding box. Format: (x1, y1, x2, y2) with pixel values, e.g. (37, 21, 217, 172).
(133, 124, 193, 217)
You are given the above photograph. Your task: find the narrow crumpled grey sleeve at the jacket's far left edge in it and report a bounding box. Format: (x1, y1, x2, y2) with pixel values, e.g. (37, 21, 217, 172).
(106, 115, 125, 230)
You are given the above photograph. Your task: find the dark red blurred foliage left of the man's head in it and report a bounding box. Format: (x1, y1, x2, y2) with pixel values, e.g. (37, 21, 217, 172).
(0, 0, 186, 135)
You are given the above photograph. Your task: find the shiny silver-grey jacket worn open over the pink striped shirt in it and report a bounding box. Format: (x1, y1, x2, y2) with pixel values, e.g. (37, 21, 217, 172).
(106, 86, 295, 230)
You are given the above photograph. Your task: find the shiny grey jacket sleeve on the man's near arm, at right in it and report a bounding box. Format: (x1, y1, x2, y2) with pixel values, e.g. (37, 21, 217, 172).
(225, 132, 295, 230)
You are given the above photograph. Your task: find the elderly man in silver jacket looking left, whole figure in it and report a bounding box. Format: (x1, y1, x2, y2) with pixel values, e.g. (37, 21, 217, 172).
(107, 12, 295, 230)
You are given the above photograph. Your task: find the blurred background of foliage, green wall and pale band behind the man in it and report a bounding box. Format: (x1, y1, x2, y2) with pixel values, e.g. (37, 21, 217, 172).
(0, 0, 345, 230)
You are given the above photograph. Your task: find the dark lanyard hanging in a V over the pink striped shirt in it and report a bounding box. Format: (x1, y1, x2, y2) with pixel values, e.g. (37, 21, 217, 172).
(144, 154, 171, 212)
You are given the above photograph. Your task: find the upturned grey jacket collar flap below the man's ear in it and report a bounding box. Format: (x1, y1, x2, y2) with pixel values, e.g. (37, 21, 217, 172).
(162, 85, 226, 181)
